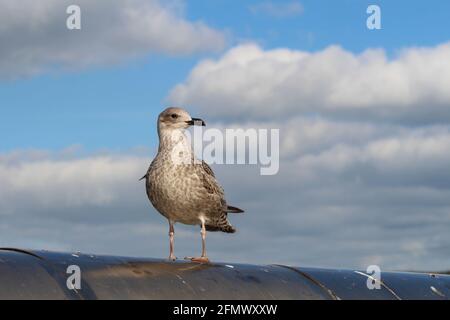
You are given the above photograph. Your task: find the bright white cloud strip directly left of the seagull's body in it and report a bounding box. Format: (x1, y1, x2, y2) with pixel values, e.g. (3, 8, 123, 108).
(0, 152, 146, 213)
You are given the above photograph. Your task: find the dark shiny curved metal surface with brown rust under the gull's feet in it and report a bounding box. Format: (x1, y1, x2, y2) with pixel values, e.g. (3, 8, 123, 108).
(0, 248, 450, 300)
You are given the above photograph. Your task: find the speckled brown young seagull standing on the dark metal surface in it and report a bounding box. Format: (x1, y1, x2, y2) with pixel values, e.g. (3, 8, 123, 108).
(140, 107, 244, 263)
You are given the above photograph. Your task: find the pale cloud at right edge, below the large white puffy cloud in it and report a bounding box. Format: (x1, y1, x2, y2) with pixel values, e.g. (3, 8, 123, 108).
(297, 128, 450, 189)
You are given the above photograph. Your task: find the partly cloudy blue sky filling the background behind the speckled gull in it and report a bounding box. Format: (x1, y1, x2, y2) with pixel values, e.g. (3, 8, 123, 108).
(0, 0, 450, 270)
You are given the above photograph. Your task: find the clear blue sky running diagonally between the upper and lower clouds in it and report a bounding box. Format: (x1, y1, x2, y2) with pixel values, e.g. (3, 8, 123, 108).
(0, 0, 450, 152)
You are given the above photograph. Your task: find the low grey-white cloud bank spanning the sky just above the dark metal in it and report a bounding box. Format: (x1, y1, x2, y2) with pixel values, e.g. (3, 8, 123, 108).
(0, 117, 450, 270)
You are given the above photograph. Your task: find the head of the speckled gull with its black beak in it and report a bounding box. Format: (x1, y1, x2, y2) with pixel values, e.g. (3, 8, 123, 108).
(158, 107, 205, 130)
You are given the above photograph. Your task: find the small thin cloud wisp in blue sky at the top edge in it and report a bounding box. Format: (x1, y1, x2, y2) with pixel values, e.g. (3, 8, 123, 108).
(249, 1, 303, 18)
